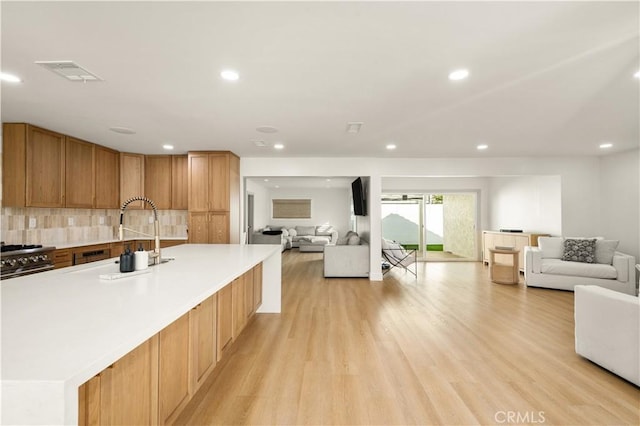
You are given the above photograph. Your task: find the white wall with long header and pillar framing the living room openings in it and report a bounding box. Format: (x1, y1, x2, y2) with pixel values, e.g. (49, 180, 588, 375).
(241, 157, 640, 280)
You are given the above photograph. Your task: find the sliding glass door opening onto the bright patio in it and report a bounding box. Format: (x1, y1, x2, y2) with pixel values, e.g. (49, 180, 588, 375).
(381, 193, 478, 261)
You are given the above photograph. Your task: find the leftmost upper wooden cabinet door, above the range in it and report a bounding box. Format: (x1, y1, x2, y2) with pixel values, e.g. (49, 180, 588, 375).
(26, 126, 65, 207)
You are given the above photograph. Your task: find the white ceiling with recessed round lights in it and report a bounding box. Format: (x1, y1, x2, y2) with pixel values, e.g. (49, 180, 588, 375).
(1, 1, 640, 157)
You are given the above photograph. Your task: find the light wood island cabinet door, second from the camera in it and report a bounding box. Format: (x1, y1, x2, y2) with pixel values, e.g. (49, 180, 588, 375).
(158, 313, 190, 424)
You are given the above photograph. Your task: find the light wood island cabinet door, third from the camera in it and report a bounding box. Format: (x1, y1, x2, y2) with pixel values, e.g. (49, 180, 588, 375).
(189, 294, 218, 393)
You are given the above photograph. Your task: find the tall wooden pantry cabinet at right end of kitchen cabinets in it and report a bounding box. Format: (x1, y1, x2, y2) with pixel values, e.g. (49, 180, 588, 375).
(188, 151, 240, 244)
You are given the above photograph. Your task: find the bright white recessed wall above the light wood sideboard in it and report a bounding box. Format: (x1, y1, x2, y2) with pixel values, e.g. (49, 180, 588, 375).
(489, 176, 562, 236)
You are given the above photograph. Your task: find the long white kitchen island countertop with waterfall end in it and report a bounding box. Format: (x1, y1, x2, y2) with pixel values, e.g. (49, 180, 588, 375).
(0, 244, 281, 424)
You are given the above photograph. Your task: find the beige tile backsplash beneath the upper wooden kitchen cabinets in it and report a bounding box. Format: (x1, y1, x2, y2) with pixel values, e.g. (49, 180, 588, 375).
(0, 207, 187, 245)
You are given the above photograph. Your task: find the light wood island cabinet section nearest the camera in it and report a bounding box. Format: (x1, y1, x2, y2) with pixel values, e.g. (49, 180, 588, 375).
(78, 335, 158, 425)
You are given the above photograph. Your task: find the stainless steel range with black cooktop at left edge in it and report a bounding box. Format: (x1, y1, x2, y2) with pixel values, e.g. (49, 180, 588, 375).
(0, 244, 56, 280)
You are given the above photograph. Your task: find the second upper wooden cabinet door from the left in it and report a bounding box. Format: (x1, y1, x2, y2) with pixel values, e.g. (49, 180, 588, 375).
(65, 137, 95, 208)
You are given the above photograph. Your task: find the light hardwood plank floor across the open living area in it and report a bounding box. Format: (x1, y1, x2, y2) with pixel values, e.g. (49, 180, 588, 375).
(178, 251, 640, 425)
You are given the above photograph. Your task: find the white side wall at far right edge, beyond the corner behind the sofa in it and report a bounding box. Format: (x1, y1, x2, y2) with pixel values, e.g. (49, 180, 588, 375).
(598, 149, 640, 263)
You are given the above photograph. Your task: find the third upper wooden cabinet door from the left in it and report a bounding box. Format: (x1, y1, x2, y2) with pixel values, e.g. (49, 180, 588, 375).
(94, 145, 120, 209)
